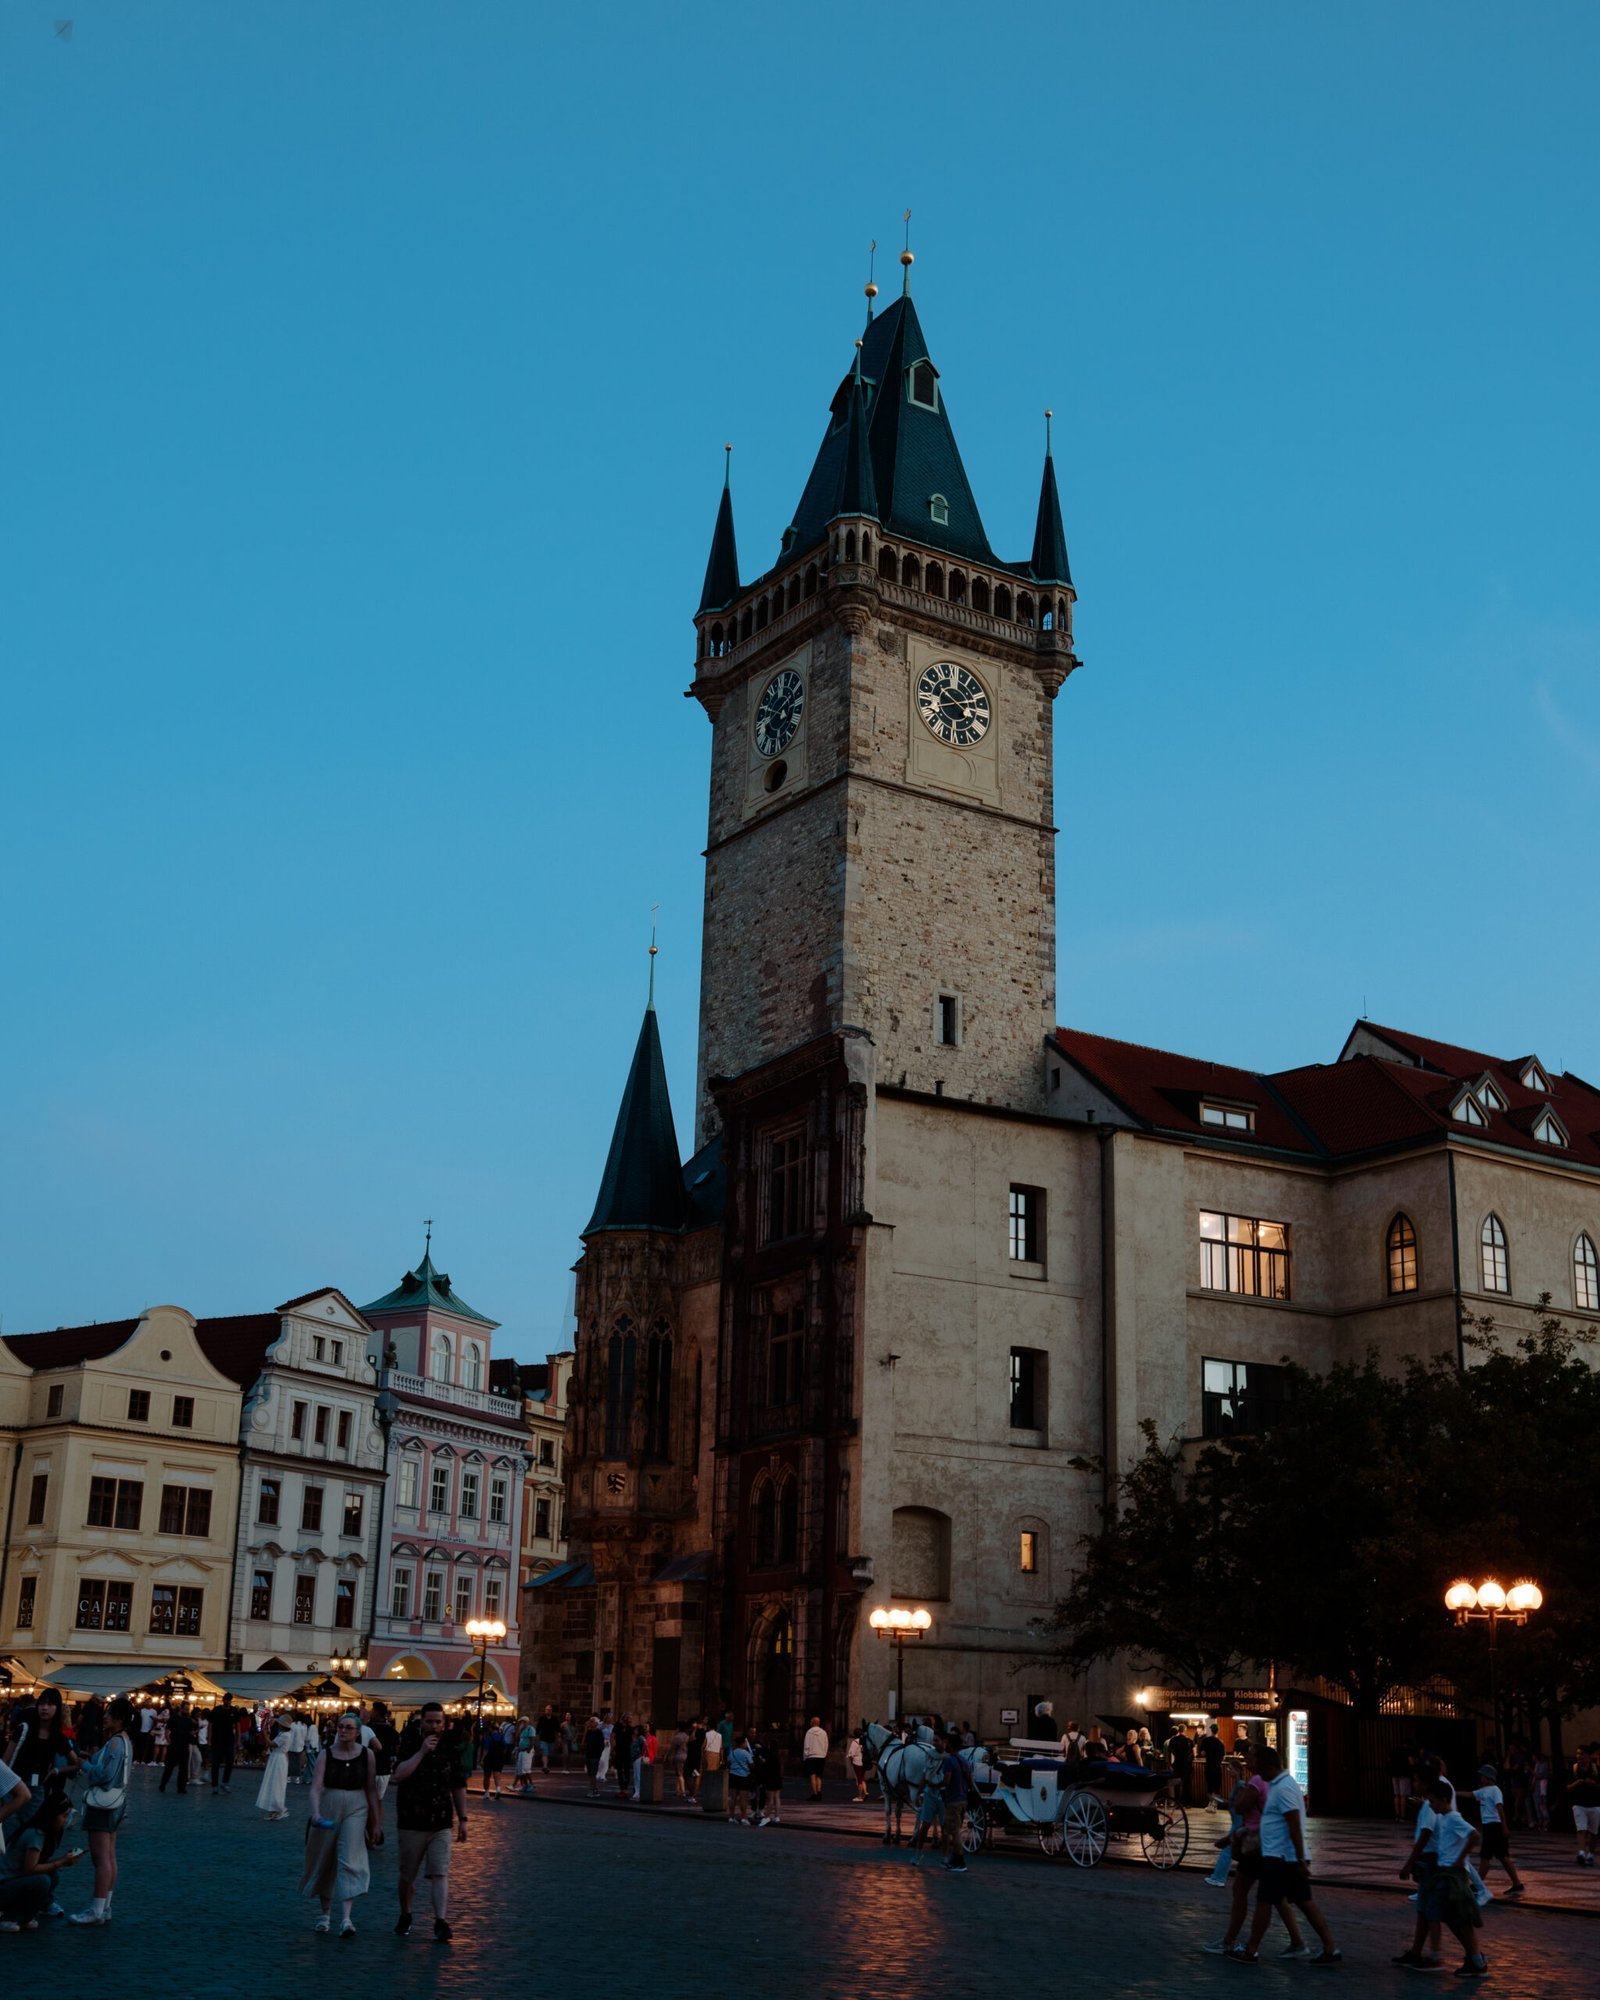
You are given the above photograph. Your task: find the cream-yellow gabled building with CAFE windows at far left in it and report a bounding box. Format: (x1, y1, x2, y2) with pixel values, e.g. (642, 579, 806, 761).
(0, 1306, 240, 1674)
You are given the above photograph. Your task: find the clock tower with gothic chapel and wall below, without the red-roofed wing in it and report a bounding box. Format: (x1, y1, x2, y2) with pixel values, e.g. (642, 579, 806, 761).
(524, 256, 1098, 1730)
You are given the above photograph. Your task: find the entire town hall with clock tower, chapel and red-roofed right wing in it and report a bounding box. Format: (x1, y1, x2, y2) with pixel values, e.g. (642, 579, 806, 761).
(522, 256, 1600, 1736)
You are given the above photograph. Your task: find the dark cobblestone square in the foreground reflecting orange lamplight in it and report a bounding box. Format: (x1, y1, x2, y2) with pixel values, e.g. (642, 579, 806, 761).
(15, 1772, 1600, 2000)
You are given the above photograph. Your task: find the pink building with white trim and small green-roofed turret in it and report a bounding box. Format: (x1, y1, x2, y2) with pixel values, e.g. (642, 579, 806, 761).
(364, 1238, 530, 1700)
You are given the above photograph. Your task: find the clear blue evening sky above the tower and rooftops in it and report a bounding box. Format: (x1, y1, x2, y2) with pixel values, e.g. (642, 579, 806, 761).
(0, 0, 1600, 1356)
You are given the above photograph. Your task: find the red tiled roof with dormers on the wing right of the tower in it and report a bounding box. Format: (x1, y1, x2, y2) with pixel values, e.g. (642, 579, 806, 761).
(1056, 1022, 1600, 1166)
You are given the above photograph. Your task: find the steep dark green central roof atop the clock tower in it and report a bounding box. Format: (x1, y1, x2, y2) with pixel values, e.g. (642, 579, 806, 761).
(784, 296, 994, 562)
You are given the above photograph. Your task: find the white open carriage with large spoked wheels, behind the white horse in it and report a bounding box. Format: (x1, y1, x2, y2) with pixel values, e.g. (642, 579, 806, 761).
(962, 1744, 1188, 1868)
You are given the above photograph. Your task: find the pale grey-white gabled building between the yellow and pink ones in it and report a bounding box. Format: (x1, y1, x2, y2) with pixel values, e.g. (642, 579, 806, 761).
(198, 1290, 384, 1672)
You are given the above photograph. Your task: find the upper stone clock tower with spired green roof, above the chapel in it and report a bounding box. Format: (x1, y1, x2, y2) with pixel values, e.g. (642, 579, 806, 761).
(692, 266, 1076, 1140)
